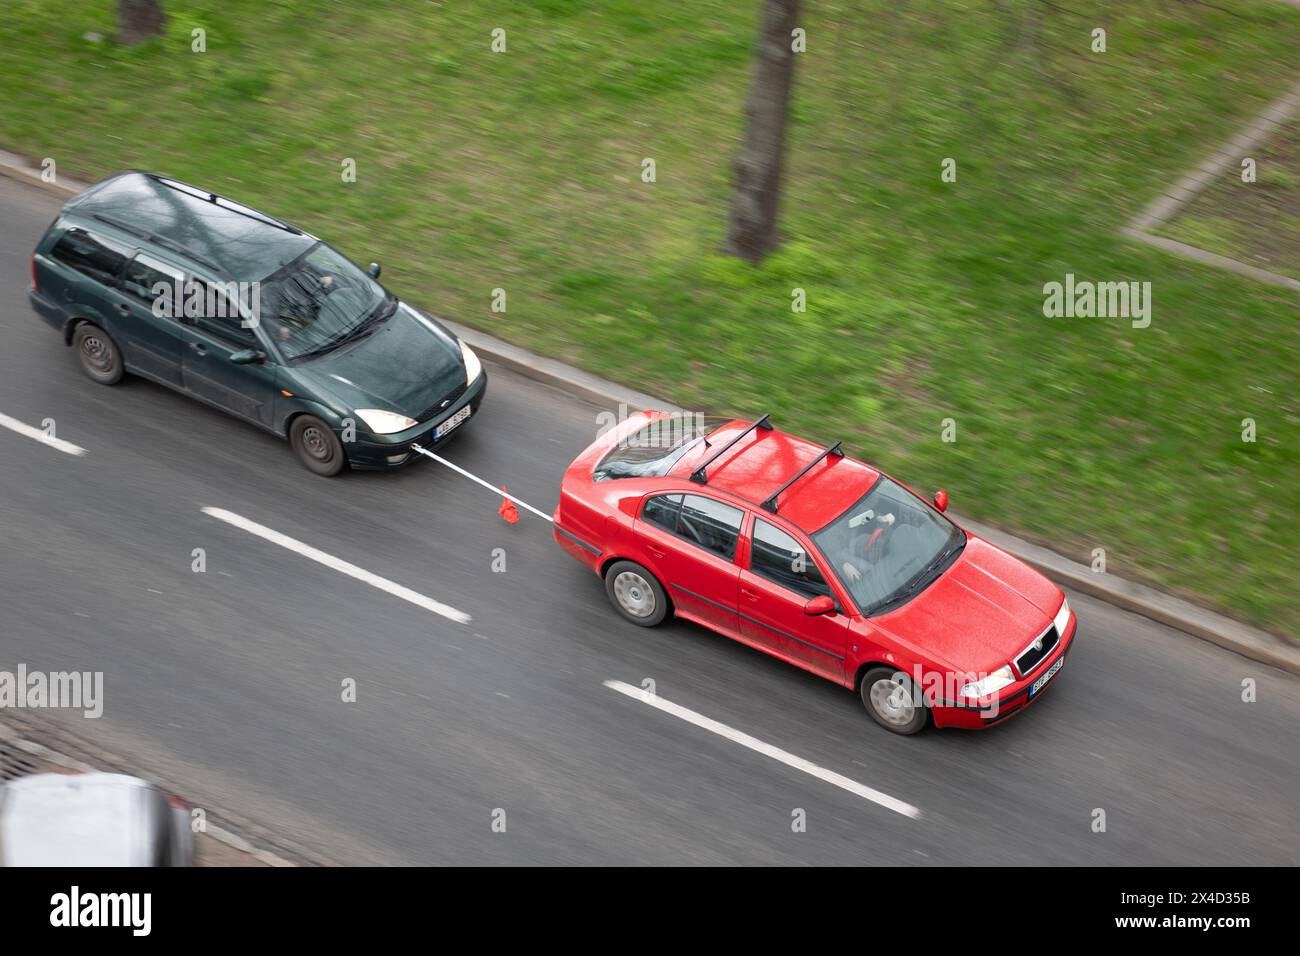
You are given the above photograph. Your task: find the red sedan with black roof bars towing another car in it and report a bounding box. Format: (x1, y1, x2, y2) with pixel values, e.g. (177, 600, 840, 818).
(555, 412, 1076, 734)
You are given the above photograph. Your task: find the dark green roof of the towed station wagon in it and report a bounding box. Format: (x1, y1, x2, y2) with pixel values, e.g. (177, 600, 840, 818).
(64, 172, 317, 282)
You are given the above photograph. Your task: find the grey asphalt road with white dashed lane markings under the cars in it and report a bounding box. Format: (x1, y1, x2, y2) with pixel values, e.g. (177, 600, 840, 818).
(0, 171, 1300, 865)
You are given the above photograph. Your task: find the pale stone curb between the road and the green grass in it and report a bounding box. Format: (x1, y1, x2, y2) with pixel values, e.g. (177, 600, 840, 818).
(0, 151, 1300, 675)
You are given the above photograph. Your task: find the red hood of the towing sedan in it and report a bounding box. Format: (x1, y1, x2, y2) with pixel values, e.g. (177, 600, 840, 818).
(875, 535, 1062, 672)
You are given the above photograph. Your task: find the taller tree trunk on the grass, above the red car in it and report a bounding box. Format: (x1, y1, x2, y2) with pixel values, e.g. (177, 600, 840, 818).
(725, 0, 800, 265)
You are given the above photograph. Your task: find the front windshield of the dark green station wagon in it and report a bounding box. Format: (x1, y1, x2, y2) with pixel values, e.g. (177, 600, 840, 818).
(259, 242, 395, 359)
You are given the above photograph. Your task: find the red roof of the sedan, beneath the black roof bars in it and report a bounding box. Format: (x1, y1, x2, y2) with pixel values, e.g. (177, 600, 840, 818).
(668, 421, 880, 532)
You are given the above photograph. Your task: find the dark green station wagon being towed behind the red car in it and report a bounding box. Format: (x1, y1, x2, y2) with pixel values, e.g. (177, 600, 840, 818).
(30, 172, 488, 475)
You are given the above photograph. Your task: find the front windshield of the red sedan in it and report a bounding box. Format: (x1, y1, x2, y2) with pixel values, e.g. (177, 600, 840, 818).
(813, 476, 966, 617)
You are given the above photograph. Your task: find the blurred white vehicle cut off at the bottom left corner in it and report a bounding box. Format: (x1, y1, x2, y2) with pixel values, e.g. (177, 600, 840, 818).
(0, 773, 194, 866)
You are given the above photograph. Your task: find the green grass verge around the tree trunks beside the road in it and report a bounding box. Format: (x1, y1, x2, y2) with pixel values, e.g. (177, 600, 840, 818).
(0, 0, 1300, 642)
